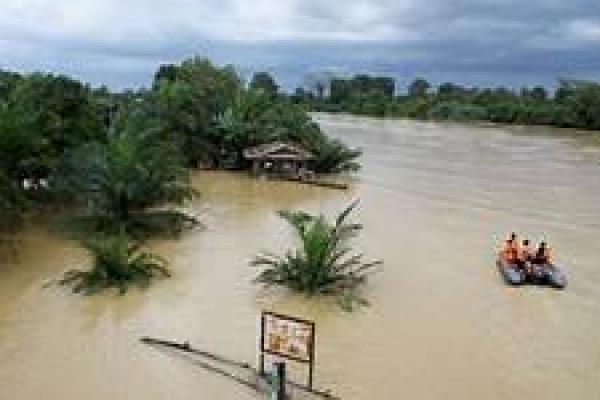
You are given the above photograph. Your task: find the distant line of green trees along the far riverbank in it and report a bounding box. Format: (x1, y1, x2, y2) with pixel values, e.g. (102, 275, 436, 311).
(291, 75, 600, 130)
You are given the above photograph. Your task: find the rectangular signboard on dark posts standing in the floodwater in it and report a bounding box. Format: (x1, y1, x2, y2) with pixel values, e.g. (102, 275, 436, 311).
(260, 311, 315, 388)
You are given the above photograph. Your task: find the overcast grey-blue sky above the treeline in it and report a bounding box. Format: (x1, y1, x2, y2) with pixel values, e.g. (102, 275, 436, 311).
(0, 0, 600, 88)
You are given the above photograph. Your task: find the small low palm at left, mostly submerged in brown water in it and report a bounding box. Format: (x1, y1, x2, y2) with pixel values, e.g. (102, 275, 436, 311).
(59, 232, 170, 294)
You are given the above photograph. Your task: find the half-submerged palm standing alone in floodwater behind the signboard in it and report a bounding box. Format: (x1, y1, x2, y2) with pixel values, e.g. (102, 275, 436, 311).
(252, 202, 382, 309)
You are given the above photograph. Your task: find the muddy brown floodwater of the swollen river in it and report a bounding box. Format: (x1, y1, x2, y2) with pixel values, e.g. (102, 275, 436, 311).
(0, 115, 600, 400)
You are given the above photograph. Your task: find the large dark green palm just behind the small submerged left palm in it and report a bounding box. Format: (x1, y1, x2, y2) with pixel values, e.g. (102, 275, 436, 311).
(55, 130, 197, 236)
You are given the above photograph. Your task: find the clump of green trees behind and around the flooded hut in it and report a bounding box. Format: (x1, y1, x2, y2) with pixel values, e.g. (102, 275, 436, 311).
(116, 58, 360, 173)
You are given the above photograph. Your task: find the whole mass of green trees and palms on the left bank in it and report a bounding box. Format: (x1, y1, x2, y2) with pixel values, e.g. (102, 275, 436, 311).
(0, 58, 360, 291)
